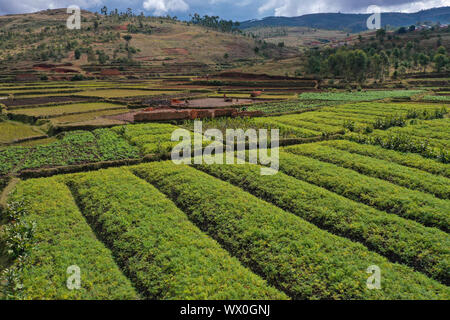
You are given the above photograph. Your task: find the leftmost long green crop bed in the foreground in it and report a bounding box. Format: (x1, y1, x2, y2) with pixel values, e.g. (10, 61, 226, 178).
(3, 178, 139, 300)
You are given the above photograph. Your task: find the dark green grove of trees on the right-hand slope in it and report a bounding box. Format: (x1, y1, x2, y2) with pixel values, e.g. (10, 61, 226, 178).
(305, 35, 450, 84)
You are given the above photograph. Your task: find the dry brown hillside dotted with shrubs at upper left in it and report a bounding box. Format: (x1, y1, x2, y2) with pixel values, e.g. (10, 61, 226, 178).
(0, 9, 297, 79)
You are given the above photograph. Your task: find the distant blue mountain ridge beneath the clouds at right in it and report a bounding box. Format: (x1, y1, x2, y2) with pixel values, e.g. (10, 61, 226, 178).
(241, 7, 450, 32)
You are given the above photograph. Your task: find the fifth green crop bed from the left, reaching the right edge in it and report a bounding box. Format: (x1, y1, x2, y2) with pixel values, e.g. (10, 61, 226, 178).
(280, 152, 450, 232)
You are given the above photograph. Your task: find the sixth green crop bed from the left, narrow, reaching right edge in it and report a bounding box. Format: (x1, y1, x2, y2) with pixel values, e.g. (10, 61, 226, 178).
(284, 143, 450, 199)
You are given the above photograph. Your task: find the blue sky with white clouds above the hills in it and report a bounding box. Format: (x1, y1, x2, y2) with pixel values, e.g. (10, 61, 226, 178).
(0, 0, 450, 21)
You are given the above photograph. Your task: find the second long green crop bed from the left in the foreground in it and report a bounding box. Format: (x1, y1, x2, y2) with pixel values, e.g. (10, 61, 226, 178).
(65, 169, 287, 300)
